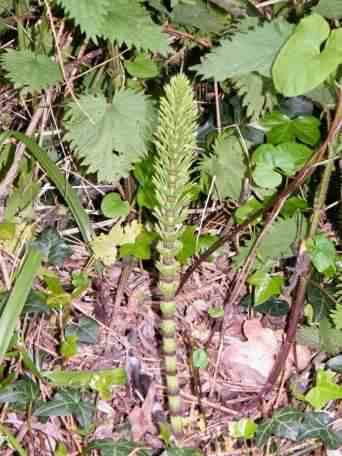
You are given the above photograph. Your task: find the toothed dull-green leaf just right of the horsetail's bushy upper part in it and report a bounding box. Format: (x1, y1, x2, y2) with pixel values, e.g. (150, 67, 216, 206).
(200, 135, 248, 201)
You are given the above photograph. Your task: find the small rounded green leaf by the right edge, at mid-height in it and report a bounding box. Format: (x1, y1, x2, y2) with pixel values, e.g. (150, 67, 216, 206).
(307, 234, 336, 276)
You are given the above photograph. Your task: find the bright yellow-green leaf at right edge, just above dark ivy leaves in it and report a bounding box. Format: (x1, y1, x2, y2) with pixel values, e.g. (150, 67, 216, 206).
(305, 369, 342, 410)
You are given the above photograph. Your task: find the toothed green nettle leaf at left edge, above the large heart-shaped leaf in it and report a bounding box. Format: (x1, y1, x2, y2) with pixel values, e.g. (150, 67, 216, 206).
(0, 49, 62, 92)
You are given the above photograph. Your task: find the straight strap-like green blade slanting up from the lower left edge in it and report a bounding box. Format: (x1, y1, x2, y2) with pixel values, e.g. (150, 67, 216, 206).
(0, 247, 43, 363)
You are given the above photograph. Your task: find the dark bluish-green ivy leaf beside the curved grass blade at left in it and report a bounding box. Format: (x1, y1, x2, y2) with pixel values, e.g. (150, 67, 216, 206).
(33, 227, 72, 266)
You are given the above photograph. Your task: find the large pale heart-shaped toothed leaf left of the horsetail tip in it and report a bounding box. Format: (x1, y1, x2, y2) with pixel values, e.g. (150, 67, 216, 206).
(65, 89, 152, 183)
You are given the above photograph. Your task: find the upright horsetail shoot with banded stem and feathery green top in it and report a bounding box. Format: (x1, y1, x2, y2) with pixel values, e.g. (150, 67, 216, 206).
(153, 75, 197, 440)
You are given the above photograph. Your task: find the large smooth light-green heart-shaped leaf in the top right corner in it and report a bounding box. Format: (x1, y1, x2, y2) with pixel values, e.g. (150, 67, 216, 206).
(272, 14, 342, 97)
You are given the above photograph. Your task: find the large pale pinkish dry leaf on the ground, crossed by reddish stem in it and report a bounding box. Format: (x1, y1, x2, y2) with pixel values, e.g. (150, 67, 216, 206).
(222, 319, 311, 389)
